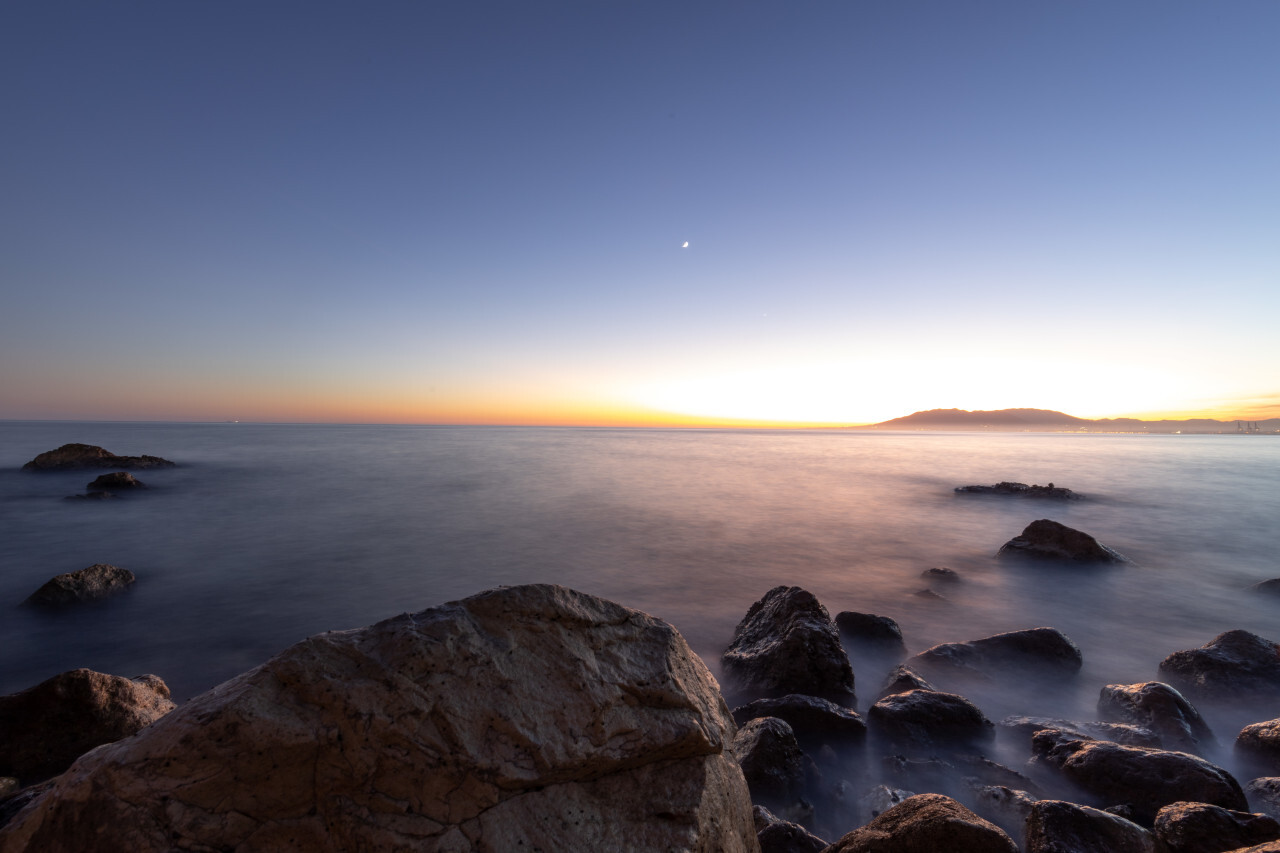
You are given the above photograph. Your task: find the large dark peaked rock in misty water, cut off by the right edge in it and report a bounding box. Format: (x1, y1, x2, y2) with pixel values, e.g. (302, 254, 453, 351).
(1160, 630, 1280, 704)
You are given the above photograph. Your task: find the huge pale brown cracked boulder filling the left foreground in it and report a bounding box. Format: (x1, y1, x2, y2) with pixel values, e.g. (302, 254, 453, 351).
(0, 585, 756, 853)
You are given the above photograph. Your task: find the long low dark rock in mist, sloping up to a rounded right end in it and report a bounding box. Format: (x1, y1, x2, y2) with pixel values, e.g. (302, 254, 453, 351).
(906, 628, 1084, 680)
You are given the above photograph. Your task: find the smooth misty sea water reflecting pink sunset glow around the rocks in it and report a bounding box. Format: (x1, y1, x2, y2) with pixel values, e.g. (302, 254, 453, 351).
(0, 423, 1280, 758)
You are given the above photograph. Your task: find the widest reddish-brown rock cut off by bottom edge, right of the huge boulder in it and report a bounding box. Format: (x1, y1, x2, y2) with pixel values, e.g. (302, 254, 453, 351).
(827, 794, 1018, 853)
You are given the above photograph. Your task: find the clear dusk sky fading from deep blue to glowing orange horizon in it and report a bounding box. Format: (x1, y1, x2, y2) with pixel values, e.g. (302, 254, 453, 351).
(0, 0, 1280, 425)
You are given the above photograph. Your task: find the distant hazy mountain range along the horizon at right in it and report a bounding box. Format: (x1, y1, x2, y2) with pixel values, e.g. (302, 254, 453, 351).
(852, 409, 1280, 433)
